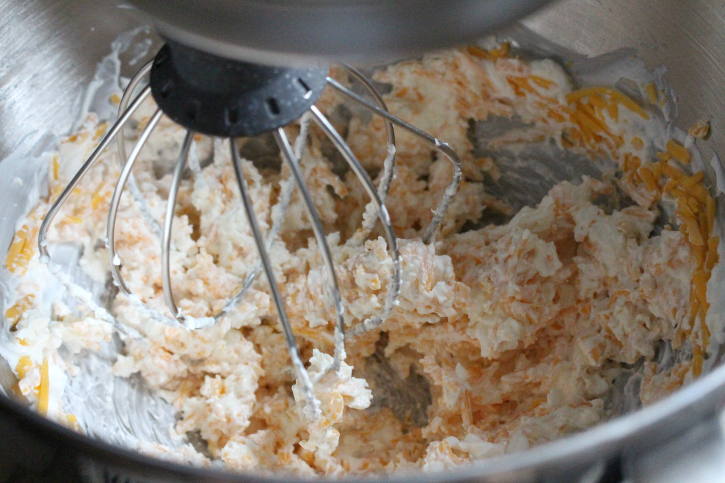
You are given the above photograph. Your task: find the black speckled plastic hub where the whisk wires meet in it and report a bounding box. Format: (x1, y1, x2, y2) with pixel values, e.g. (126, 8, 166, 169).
(150, 41, 328, 137)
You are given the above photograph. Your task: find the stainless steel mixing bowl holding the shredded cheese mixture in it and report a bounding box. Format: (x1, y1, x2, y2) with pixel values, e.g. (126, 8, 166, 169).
(0, 0, 725, 483)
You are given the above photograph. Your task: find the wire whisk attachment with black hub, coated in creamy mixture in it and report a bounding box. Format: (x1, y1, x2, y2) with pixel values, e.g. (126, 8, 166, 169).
(38, 42, 461, 421)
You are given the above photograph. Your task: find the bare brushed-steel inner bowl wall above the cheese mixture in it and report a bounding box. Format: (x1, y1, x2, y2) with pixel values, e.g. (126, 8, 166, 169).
(0, 0, 725, 478)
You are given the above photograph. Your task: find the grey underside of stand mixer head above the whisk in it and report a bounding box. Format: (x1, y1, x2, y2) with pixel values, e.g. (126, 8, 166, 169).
(116, 0, 550, 65)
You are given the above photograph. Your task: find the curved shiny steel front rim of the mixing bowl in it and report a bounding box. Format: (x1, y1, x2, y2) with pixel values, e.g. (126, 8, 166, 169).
(0, 350, 725, 483)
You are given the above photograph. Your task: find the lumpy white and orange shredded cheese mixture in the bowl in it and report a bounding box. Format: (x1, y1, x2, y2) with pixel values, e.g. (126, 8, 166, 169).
(5, 44, 719, 475)
